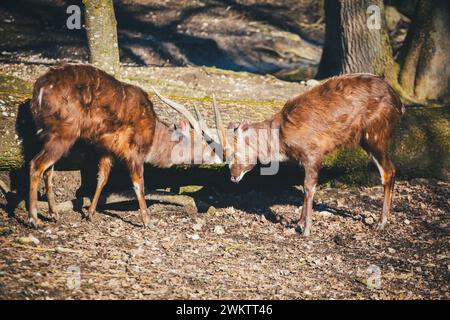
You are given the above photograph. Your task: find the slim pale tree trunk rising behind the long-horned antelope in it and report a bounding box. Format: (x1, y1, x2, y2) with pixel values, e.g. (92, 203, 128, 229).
(83, 0, 120, 77)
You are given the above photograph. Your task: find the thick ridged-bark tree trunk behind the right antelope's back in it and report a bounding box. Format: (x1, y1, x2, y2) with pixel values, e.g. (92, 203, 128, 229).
(317, 0, 397, 81)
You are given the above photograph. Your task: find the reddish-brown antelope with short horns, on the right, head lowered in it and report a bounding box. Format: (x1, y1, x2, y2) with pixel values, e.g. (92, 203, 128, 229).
(214, 74, 405, 236)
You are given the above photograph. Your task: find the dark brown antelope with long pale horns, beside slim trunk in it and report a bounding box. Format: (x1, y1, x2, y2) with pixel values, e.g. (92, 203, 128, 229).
(29, 64, 221, 227)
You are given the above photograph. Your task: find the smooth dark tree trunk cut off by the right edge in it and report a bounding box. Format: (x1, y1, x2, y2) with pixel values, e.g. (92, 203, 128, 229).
(399, 0, 450, 104)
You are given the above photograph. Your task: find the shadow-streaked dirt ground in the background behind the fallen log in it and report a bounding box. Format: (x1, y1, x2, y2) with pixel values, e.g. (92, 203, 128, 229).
(0, 0, 324, 77)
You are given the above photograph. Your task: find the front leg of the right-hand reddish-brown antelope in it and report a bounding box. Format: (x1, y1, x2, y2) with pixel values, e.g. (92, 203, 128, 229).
(300, 166, 319, 237)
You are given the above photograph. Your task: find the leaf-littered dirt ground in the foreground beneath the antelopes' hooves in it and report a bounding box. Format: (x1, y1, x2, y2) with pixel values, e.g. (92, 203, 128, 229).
(0, 172, 450, 299)
